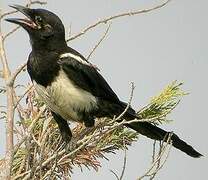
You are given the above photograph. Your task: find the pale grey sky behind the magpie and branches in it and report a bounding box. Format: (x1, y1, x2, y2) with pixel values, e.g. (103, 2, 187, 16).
(0, 0, 208, 180)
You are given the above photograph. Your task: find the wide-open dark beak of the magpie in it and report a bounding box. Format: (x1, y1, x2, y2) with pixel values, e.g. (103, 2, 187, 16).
(5, 5, 37, 29)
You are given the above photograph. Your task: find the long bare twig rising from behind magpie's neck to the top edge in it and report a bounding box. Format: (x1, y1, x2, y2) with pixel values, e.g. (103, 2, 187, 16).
(67, 0, 171, 42)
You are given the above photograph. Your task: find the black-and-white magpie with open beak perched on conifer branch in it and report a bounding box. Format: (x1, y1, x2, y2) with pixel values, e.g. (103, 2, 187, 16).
(6, 5, 202, 158)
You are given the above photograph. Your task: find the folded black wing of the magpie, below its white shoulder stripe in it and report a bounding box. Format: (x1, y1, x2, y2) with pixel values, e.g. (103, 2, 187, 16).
(58, 56, 120, 103)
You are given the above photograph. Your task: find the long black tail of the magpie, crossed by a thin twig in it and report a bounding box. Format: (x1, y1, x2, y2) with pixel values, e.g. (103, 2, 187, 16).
(126, 122, 202, 158)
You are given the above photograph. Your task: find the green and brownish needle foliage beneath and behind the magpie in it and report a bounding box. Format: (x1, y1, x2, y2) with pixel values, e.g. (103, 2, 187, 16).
(8, 81, 186, 179)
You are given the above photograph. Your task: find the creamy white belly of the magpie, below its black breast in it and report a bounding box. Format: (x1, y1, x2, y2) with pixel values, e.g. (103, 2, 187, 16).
(33, 70, 97, 122)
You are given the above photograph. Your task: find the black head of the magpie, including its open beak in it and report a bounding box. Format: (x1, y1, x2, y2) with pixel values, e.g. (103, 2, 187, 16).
(6, 5, 65, 49)
